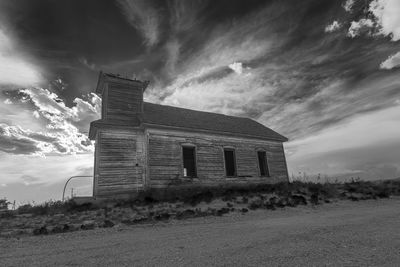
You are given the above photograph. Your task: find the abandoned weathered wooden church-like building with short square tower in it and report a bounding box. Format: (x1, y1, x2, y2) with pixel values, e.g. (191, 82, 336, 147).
(89, 73, 288, 197)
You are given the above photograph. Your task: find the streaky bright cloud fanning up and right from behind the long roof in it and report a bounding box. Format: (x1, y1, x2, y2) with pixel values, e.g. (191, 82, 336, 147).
(147, 1, 400, 146)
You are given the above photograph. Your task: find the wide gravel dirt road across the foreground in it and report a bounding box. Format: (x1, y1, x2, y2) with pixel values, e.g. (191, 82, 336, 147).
(0, 197, 400, 266)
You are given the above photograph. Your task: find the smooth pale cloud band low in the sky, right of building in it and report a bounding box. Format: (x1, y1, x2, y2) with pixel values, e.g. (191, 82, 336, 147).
(286, 106, 400, 179)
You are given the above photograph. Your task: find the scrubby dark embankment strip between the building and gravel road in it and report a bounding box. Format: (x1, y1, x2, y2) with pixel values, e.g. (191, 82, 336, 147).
(0, 181, 400, 238)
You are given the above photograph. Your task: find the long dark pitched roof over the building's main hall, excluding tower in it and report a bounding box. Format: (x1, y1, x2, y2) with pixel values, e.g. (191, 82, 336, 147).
(142, 102, 288, 142)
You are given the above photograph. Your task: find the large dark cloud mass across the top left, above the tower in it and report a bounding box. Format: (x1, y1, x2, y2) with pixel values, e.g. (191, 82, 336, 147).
(0, 0, 286, 96)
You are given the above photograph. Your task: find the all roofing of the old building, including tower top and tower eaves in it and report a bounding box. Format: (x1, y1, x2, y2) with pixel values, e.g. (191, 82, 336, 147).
(89, 72, 288, 142)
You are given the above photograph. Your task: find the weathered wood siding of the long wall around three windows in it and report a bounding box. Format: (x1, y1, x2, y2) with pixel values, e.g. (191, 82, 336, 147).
(146, 129, 288, 187)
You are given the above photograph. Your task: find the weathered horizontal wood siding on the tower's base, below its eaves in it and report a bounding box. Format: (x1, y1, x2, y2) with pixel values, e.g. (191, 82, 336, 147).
(94, 129, 146, 196)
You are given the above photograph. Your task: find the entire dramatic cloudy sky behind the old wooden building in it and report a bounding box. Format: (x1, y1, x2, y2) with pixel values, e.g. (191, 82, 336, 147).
(0, 0, 400, 202)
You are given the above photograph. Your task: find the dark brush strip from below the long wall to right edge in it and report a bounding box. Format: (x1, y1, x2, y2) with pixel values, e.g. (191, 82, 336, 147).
(106, 179, 400, 208)
